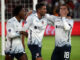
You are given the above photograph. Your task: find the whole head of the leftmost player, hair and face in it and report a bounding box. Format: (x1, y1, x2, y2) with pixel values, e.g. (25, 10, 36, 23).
(13, 5, 25, 19)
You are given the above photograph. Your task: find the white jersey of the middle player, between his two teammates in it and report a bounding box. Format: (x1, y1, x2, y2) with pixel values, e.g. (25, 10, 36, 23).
(23, 13, 51, 47)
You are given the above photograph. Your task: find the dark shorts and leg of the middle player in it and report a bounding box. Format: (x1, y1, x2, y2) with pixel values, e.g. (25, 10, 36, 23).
(28, 45, 42, 60)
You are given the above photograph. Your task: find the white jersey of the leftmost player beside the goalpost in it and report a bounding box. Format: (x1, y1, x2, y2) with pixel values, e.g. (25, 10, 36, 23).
(6, 17, 24, 53)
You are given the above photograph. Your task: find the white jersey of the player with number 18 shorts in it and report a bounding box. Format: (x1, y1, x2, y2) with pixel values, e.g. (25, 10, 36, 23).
(45, 14, 73, 47)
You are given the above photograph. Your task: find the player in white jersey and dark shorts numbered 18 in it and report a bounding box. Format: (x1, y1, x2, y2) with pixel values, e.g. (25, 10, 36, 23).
(45, 4, 73, 60)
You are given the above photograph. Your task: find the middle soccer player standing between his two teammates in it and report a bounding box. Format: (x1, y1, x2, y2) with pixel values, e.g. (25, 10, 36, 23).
(23, 3, 52, 60)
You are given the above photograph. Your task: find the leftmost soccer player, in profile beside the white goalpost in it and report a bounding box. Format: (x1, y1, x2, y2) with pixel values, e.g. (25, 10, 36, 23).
(5, 6, 28, 60)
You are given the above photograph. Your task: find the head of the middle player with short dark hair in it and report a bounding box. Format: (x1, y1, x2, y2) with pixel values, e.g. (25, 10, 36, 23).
(36, 3, 47, 16)
